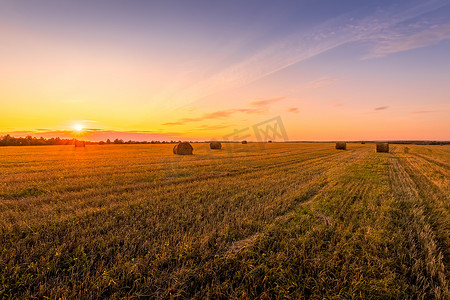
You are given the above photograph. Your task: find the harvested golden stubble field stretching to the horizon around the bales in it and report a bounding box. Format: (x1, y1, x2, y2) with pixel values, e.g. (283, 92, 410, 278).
(0, 143, 450, 299)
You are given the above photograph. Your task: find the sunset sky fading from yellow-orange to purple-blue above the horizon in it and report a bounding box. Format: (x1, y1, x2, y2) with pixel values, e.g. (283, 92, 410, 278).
(0, 0, 450, 141)
